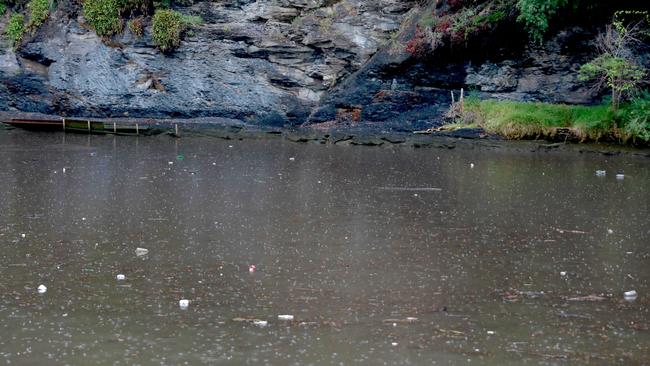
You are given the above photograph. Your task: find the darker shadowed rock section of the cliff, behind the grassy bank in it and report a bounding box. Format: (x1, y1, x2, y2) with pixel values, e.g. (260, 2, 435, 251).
(310, 22, 599, 128)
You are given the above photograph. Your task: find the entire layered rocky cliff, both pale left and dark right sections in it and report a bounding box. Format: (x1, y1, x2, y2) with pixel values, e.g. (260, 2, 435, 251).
(0, 0, 644, 129)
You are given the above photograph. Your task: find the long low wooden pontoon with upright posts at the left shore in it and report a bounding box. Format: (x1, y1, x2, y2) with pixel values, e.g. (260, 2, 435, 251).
(2, 118, 149, 135)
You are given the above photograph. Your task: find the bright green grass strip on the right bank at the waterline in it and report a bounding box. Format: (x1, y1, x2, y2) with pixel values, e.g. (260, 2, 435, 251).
(462, 93, 650, 142)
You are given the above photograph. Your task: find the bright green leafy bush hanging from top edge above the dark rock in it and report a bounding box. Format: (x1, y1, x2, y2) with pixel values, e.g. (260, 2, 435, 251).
(517, 0, 568, 43)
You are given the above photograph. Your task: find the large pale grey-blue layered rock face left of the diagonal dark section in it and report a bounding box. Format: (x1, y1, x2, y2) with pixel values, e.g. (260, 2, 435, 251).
(0, 0, 413, 125)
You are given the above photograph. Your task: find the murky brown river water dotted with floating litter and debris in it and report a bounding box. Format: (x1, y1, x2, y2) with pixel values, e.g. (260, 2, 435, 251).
(0, 130, 650, 365)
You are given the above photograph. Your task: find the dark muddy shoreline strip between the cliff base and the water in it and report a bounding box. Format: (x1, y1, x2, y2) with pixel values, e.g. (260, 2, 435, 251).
(0, 112, 650, 158)
